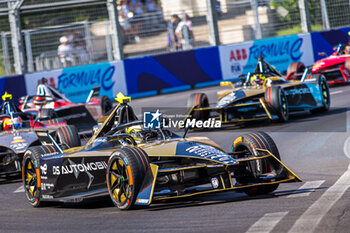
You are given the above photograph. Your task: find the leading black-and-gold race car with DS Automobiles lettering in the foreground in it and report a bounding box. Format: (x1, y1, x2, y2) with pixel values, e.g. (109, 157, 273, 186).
(23, 93, 301, 209)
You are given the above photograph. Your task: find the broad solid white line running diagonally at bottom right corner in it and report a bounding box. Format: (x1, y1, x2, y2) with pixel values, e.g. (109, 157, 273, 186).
(289, 165, 350, 233)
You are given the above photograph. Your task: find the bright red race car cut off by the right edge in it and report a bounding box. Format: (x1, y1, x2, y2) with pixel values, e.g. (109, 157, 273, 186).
(286, 44, 350, 84)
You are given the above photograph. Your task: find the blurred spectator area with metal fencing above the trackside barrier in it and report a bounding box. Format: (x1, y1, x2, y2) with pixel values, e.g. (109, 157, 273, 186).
(0, 0, 350, 76)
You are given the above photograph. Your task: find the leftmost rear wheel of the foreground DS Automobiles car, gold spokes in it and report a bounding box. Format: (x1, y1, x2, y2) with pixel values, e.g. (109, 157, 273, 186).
(22, 146, 46, 207)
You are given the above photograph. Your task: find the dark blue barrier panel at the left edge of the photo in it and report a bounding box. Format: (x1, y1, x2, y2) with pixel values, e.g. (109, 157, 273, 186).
(0, 75, 27, 103)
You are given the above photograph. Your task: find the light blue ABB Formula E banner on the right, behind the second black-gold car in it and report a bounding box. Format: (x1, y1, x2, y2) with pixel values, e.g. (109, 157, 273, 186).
(219, 33, 314, 80)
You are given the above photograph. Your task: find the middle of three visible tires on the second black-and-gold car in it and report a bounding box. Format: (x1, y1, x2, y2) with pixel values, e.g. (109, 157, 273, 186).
(265, 86, 289, 122)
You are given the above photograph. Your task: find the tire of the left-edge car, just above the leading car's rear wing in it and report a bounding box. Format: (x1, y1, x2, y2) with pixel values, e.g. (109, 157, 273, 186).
(55, 125, 81, 149)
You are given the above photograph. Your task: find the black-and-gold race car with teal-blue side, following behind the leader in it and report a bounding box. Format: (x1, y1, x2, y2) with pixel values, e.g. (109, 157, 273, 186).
(185, 57, 330, 124)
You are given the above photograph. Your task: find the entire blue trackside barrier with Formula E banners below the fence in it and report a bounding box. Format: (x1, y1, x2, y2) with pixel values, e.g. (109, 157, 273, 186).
(0, 27, 350, 102)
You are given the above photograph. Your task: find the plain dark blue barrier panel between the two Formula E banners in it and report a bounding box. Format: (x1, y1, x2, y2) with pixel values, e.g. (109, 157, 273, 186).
(124, 47, 222, 94)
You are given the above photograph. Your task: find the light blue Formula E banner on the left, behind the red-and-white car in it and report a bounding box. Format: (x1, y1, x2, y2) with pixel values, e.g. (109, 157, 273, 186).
(25, 61, 126, 103)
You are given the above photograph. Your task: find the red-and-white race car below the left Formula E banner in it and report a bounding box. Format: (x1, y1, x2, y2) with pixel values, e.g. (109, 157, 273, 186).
(19, 78, 113, 131)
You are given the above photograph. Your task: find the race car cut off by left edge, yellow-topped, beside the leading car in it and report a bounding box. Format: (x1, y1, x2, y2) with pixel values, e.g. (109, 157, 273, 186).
(0, 93, 80, 176)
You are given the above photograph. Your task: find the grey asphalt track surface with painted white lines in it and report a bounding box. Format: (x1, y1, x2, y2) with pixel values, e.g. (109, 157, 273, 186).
(0, 86, 350, 233)
